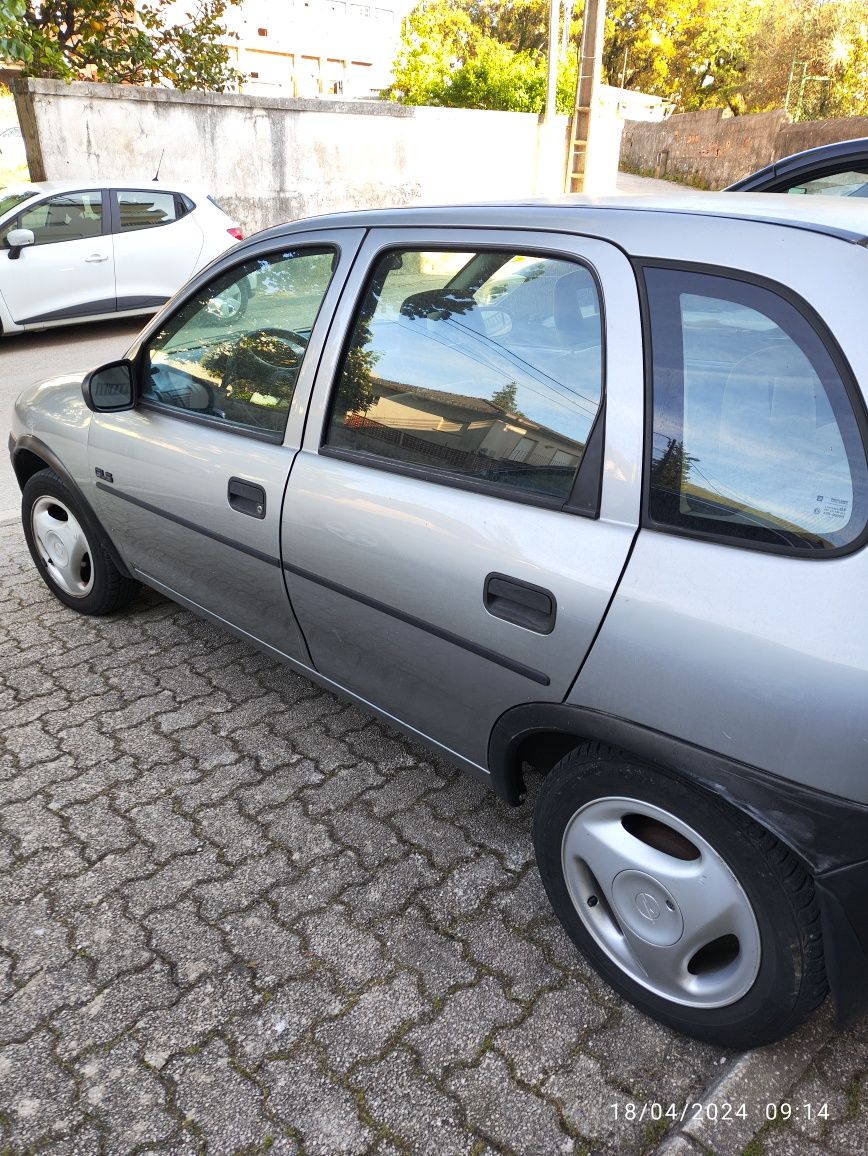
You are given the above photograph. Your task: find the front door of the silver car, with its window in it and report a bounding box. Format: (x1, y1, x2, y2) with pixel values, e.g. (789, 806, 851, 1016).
(89, 230, 362, 661)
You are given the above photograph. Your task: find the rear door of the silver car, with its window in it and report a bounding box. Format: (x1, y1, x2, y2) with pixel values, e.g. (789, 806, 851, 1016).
(282, 230, 643, 766)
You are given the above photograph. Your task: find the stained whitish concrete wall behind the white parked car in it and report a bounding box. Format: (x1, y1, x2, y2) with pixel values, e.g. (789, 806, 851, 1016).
(14, 80, 577, 232)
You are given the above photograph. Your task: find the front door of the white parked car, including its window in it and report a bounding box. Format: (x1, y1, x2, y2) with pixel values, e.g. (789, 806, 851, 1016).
(0, 188, 116, 325)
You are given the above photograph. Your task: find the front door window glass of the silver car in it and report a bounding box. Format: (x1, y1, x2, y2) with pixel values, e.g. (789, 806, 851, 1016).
(142, 247, 336, 436)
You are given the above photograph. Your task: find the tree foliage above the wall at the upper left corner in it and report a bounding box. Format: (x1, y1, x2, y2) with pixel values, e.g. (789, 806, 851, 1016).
(0, 0, 242, 91)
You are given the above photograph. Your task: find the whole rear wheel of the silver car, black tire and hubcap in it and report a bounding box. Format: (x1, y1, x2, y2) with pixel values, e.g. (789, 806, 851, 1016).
(534, 743, 826, 1047)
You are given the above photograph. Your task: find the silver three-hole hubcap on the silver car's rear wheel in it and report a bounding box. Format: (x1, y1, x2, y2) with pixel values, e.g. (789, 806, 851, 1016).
(561, 798, 761, 1008)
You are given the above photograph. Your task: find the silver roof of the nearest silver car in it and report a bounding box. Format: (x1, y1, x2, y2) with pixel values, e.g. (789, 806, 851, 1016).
(250, 191, 868, 245)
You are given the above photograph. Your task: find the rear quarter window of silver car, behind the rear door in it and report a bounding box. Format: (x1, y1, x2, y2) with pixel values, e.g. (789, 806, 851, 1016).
(645, 267, 868, 551)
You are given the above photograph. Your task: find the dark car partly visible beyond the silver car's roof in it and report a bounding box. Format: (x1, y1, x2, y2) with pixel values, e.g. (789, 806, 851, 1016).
(726, 136, 868, 197)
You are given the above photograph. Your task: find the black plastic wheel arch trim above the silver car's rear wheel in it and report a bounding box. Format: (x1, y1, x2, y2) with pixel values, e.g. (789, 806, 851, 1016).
(489, 703, 868, 1024)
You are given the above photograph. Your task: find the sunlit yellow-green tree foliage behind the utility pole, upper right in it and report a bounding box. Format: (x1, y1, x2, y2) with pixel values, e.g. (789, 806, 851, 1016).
(391, 0, 868, 119)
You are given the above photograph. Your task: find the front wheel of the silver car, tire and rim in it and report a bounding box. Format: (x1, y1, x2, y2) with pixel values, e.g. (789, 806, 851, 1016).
(21, 469, 141, 615)
